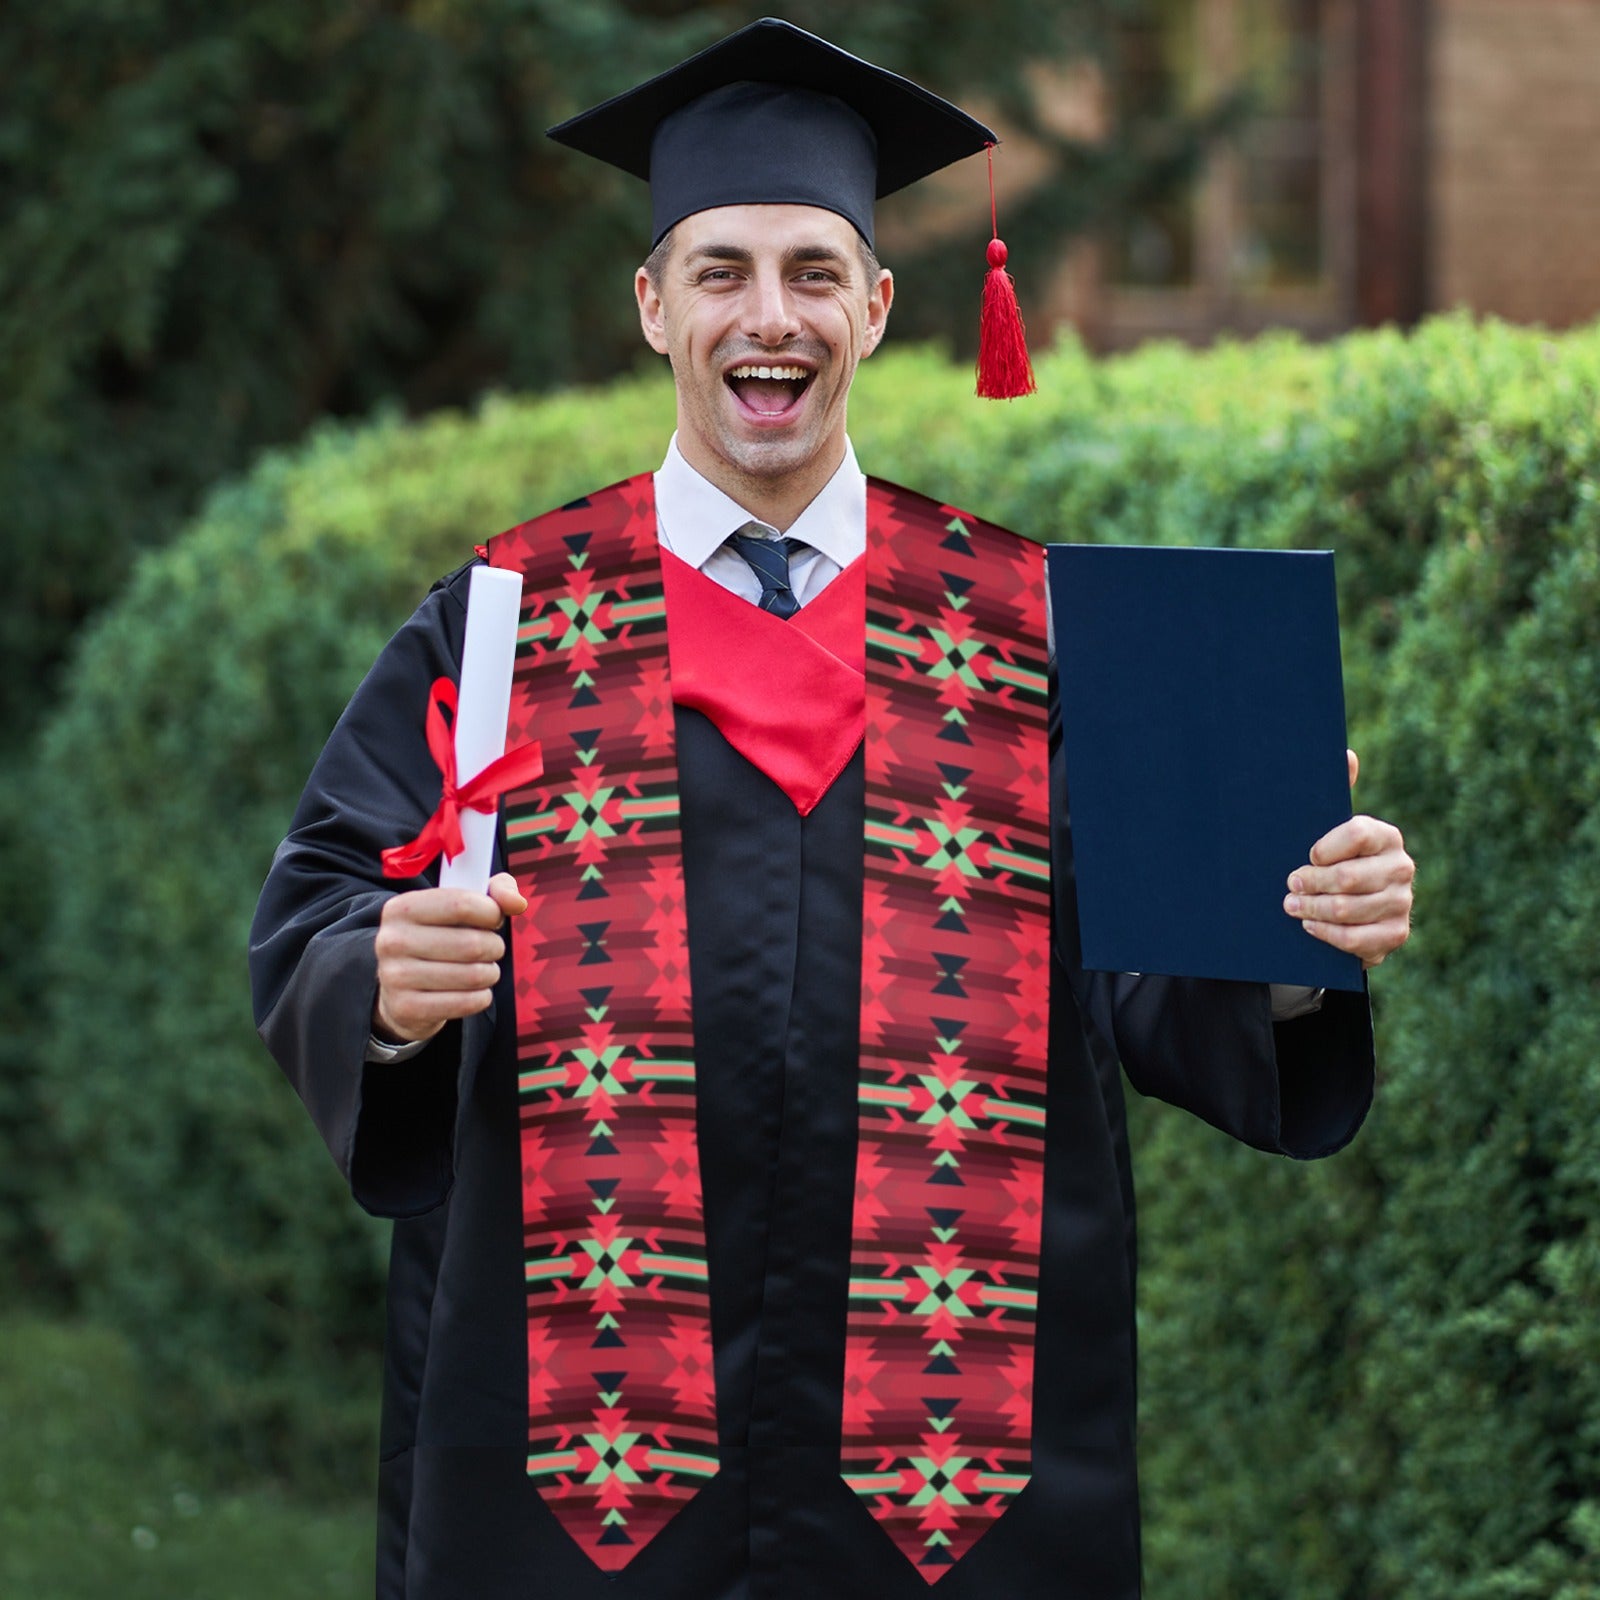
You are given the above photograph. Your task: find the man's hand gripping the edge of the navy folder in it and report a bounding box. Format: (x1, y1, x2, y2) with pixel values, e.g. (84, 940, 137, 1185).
(1283, 750, 1416, 966)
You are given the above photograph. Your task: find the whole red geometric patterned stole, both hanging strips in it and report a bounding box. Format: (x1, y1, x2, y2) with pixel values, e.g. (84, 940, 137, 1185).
(490, 475, 1050, 1582)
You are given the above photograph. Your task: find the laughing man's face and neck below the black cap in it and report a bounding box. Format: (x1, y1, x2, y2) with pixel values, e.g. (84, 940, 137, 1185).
(635, 205, 894, 528)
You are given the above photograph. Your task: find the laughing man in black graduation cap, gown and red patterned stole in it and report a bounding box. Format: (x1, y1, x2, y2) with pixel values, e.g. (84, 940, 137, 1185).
(253, 22, 1411, 1600)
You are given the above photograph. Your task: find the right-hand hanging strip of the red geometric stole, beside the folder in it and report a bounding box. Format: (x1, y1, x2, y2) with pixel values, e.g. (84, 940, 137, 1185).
(843, 485, 1050, 1582)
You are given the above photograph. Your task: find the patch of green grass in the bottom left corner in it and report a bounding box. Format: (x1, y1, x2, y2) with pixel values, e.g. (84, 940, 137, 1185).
(0, 1317, 373, 1600)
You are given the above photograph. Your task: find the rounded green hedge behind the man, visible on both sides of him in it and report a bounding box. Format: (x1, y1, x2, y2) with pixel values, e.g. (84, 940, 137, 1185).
(31, 320, 1600, 1600)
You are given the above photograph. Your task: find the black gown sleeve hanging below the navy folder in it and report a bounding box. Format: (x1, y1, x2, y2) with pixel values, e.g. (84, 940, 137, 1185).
(1051, 681, 1374, 1160)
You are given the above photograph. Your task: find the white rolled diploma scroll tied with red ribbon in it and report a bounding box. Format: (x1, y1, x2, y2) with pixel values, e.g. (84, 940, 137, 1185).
(438, 566, 522, 894)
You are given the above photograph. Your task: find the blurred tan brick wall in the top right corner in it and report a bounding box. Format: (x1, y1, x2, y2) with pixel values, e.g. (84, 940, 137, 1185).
(1429, 0, 1600, 326)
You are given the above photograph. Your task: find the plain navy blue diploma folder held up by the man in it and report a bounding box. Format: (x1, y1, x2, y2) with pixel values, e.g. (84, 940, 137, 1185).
(1048, 544, 1362, 989)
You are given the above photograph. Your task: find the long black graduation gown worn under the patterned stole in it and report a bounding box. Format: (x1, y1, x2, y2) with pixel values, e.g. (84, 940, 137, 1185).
(251, 556, 1373, 1600)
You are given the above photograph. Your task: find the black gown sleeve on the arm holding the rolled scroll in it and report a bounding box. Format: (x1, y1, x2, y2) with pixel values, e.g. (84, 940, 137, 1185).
(250, 568, 493, 1218)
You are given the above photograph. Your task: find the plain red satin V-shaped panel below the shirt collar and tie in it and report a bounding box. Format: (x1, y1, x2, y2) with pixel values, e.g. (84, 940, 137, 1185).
(661, 550, 867, 816)
